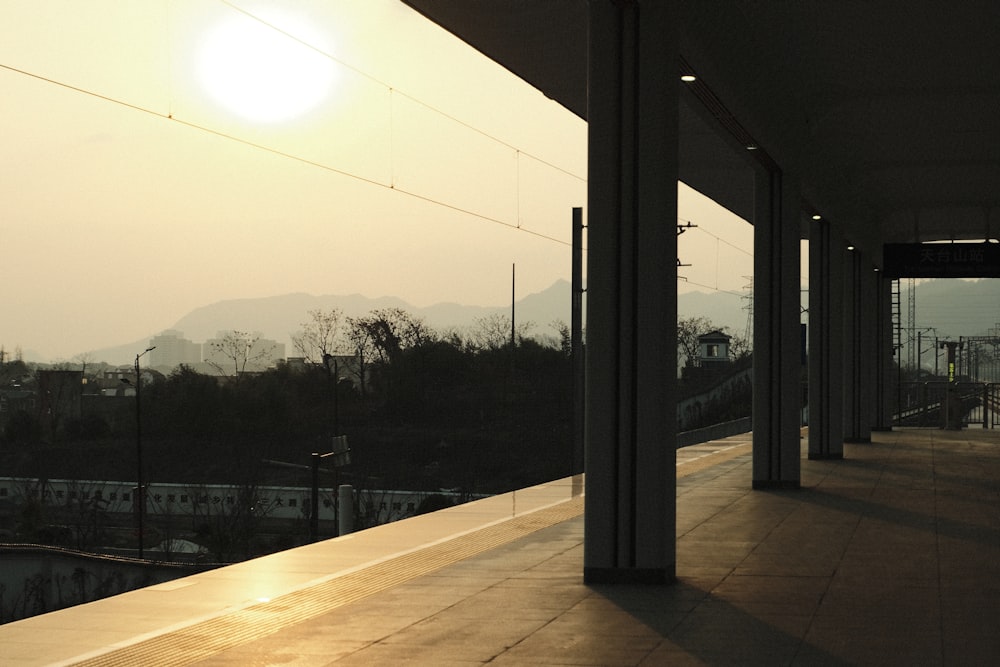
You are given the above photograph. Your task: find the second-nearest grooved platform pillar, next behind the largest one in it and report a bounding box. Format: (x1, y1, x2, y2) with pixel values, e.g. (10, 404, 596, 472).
(753, 171, 802, 489)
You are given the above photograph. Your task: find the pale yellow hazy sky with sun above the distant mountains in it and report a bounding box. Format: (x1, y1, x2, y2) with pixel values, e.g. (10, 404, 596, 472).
(0, 0, 752, 359)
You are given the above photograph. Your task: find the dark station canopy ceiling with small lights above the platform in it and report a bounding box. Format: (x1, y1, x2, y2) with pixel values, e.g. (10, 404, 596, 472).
(403, 0, 1000, 256)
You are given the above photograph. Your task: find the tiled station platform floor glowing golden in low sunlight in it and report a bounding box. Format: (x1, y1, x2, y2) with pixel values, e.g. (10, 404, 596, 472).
(0, 429, 1000, 667)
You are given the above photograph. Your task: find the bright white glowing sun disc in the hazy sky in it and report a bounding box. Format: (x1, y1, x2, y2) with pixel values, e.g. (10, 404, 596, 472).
(198, 15, 335, 123)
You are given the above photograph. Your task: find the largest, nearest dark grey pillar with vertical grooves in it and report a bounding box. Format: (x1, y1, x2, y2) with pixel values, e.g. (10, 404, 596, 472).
(584, 2, 678, 583)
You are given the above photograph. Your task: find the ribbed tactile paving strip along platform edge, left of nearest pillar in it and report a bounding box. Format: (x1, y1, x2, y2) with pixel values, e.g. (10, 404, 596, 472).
(76, 496, 583, 667)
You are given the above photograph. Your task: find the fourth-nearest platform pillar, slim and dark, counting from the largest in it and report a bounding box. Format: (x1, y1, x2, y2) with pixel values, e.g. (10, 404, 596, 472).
(844, 248, 875, 442)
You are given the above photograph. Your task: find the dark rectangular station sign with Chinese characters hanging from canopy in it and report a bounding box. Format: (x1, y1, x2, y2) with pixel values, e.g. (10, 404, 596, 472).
(882, 243, 1000, 278)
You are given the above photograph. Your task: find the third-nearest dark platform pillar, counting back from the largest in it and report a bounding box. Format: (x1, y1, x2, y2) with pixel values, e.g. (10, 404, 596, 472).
(809, 220, 844, 460)
